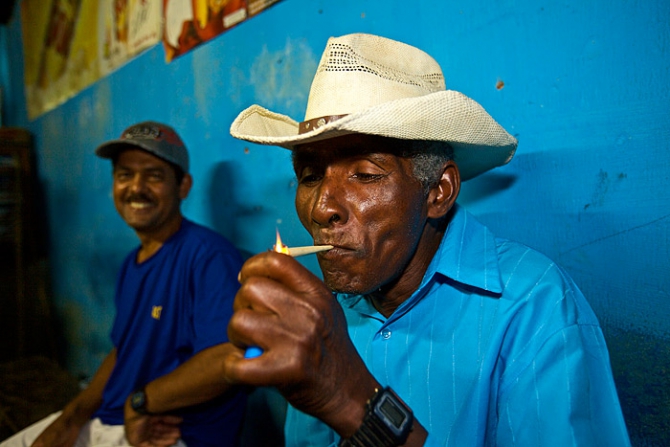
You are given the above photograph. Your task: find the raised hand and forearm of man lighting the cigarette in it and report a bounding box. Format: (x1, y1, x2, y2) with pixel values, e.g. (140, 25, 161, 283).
(225, 253, 427, 446)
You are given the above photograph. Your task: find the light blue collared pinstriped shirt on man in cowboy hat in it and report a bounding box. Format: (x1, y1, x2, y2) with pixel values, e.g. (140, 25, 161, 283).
(285, 207, 630, 447)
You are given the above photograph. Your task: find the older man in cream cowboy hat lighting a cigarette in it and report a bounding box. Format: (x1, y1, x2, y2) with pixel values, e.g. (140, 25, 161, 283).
(226, 34, 629, 447)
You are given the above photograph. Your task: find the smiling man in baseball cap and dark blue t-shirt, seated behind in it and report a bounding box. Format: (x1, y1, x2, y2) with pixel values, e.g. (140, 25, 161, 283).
(1, 122, 246, 447)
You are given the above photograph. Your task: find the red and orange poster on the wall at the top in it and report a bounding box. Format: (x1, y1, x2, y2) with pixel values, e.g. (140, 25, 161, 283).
(163, 0, 280, 62)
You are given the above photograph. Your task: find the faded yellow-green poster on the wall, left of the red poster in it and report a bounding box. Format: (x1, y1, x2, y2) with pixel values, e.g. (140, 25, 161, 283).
(21, 0, 162, 120)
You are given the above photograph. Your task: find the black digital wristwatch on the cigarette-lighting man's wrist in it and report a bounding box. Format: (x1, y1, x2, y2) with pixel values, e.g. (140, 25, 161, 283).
(339, 387, 414, 447)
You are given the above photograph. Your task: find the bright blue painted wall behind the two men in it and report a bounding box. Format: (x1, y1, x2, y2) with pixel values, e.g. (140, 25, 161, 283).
(0, 0, 670, 446)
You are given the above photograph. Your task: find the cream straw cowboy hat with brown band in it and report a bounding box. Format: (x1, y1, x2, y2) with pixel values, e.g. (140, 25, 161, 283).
(230, 34, 517, 180)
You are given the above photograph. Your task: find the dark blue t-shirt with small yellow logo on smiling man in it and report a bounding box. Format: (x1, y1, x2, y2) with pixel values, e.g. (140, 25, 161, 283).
(95, 219, 246, 446)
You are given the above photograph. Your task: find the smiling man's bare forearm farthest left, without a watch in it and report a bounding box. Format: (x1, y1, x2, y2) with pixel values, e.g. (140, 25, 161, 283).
(33, 349, 116, 447)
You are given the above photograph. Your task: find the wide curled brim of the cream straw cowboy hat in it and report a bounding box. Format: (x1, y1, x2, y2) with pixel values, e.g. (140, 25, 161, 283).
(230, 90, 517, 180)
